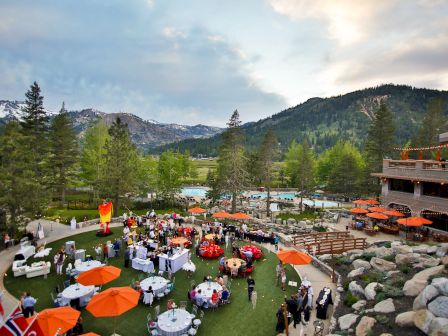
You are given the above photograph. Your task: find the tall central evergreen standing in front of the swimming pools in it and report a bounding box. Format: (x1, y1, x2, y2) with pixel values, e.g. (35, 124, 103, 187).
(217, 110, 248, 212)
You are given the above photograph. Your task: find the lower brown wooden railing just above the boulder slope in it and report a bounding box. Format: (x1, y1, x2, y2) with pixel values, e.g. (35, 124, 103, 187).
(297, 238, 367, 255)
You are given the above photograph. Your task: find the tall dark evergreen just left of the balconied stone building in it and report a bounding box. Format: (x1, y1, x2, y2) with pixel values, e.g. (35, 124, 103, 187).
(364, 102, 395, 193)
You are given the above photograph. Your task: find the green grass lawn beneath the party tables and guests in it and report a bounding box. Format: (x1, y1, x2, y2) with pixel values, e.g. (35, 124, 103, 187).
(5, 228, 300, 336)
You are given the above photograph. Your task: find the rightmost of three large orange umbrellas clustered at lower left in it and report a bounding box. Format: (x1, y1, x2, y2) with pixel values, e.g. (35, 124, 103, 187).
(86, 287, 140, 335)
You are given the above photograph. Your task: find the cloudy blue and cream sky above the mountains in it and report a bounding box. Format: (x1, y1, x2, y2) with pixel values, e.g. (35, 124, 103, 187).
(0, 0, 448, 126)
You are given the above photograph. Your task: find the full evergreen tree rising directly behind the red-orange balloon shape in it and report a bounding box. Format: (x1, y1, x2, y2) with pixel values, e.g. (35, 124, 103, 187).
(100, 118, 139, 211)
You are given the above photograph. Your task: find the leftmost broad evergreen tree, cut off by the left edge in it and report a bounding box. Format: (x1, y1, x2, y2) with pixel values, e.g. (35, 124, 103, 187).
(0, 121, 39, 230)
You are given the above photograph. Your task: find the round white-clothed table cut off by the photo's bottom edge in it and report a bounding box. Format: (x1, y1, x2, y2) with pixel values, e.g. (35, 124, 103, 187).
(157, 309, 194, 336)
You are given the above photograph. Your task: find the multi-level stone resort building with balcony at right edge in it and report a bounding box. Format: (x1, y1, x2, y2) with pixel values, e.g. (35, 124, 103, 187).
(372, 133, 448, 231)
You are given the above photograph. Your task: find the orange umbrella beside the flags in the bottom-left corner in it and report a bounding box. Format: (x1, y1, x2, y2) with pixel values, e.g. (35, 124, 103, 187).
(31, 307, 81, 336)
